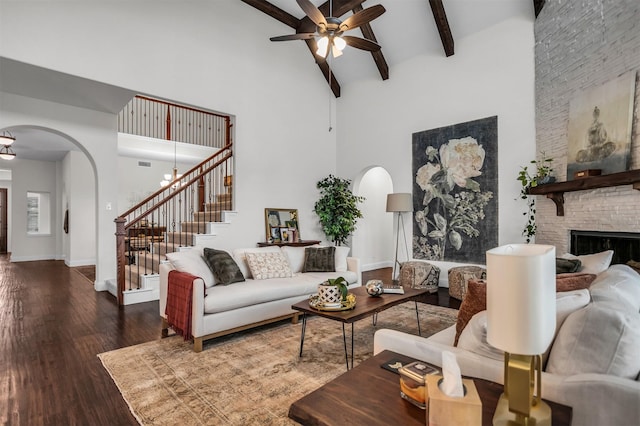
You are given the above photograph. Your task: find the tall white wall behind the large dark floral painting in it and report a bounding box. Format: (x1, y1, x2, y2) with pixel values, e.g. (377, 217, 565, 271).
(337, 17, 535, 264)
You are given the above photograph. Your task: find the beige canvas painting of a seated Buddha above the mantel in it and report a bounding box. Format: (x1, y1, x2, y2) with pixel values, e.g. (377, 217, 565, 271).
(567, 71, 636, 180)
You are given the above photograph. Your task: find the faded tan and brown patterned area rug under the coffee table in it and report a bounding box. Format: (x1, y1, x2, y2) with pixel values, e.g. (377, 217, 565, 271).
(98, 302, 458, 425)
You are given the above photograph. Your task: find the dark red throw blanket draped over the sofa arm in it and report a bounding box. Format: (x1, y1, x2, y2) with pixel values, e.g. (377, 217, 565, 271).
(164, 270, 198, 340)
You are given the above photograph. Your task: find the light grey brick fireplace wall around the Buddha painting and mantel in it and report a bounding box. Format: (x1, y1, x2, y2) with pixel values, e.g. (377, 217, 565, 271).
(535, 0, 640, 254)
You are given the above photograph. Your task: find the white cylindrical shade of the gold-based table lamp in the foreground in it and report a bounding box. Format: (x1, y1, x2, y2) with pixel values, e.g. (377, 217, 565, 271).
(487, 244, 556, 355)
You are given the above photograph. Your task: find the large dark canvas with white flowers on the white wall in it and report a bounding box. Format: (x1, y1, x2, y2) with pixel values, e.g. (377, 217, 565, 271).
(412, 117, 498, 263)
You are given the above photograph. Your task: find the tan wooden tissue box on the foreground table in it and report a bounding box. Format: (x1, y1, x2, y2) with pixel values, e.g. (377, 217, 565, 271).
(426, 375, 482, 426)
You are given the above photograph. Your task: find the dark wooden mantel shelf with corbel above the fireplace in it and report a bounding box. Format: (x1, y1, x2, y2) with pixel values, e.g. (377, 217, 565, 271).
(528, 170, 640, 216)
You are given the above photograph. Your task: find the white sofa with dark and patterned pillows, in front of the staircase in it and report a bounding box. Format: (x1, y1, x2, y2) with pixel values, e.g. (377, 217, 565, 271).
(160, 247, 362, 352)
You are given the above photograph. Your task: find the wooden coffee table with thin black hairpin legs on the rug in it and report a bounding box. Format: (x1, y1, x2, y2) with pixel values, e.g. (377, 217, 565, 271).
(291, 287, 429, 370)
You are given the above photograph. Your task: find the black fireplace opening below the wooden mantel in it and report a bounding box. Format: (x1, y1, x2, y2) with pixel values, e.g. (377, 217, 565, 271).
(571, 230, 640, 264)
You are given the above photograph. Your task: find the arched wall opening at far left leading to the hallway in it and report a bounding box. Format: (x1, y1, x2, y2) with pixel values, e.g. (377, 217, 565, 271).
(0, 125, 97, 266)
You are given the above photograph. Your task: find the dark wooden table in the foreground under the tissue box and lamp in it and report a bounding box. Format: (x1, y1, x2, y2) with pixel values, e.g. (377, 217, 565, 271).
(289, 351, 573, 426)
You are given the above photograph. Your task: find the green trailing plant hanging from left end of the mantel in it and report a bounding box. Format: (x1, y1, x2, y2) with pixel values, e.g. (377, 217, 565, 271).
(517, 152, 556, 243)
